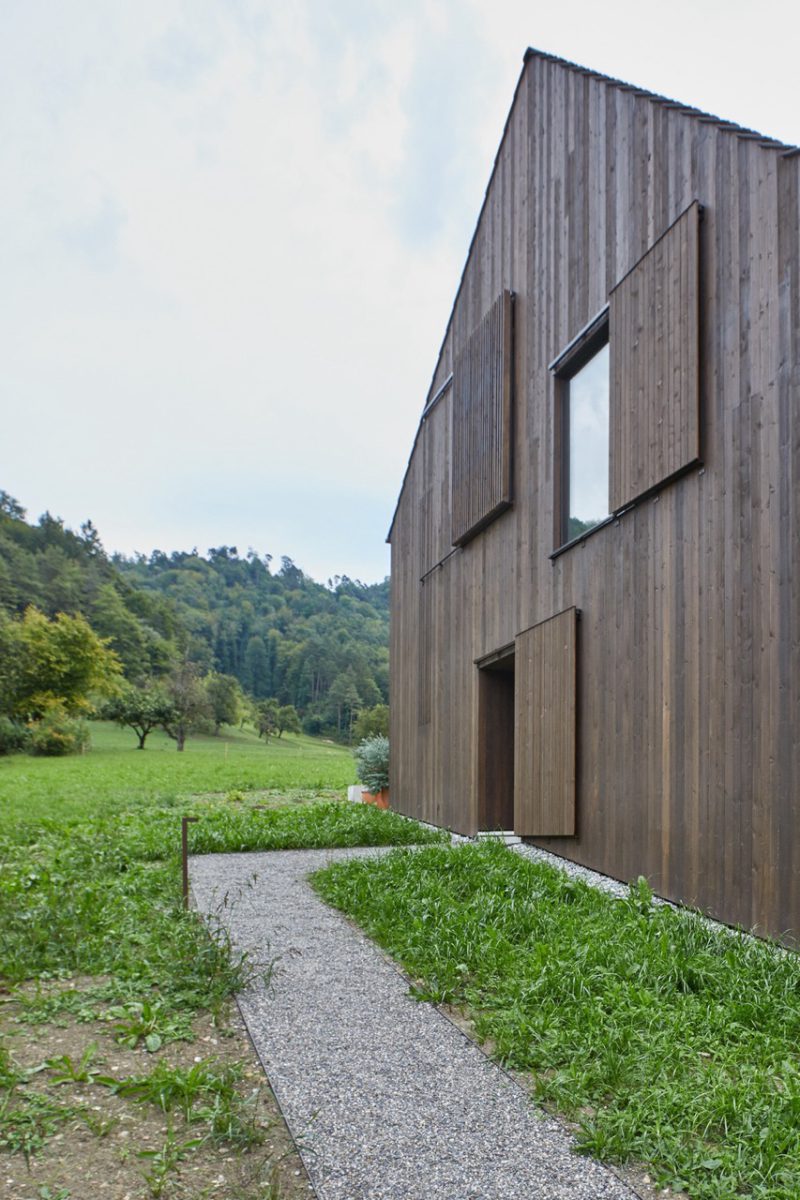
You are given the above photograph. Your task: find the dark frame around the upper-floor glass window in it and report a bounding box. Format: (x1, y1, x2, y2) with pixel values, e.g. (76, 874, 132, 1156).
(548, 304, 614, 558)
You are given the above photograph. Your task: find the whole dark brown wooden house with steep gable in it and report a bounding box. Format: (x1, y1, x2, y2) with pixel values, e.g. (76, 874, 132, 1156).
(389, 50, 800, 936)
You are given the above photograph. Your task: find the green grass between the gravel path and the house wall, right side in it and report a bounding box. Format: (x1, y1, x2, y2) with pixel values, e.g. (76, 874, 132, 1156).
(314, 846, 800, 1200)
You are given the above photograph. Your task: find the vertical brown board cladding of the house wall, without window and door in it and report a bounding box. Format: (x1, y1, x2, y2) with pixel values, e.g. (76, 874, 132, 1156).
(391, 46, 800, 937)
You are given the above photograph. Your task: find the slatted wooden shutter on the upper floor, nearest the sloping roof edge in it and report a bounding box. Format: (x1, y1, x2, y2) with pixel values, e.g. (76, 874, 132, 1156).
(451, 292, 513, 546)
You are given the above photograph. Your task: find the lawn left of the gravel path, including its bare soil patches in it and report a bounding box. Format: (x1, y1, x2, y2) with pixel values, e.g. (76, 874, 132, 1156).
(0, 725, 443, 1200)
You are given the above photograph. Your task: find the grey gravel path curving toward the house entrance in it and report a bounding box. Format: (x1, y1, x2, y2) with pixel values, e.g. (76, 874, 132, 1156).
(191, 850, 634, 1200)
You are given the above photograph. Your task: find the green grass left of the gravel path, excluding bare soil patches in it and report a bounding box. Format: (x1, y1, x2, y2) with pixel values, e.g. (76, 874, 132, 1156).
(0, 725, 439, 1180)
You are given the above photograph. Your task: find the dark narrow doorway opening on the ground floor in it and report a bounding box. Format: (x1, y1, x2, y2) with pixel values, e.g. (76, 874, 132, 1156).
(477, 652, 515, 830)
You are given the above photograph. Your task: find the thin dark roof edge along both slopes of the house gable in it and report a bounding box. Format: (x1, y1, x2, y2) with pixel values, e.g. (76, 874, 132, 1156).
(386, 46, 800, 542)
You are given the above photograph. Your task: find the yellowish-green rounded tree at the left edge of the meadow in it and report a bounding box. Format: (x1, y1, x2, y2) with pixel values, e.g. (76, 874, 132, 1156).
(0, 606, 120, 720)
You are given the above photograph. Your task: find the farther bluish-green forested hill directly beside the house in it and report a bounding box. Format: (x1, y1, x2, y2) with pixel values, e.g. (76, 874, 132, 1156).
(113, 546, 389, 733)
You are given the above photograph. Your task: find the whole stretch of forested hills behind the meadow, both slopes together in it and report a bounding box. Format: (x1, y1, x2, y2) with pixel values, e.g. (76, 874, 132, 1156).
(0, 492, 389, 733)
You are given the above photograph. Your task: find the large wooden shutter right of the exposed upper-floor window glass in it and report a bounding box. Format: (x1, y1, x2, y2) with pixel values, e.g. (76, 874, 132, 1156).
(609, 202, 700, 512)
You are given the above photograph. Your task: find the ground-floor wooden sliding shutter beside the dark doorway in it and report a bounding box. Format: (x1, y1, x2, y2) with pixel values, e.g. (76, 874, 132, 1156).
(513, 608, 577, 838)
